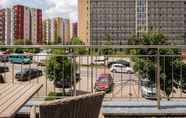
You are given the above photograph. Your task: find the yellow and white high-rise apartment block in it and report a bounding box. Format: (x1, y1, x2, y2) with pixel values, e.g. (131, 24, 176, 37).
(43, 17, 70, 44)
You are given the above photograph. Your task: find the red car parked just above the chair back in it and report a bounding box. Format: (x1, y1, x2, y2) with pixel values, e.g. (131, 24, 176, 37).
(95, 74, 114, 92)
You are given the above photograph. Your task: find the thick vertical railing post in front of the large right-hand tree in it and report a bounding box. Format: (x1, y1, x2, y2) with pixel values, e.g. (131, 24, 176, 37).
(156, 48, 161, 109)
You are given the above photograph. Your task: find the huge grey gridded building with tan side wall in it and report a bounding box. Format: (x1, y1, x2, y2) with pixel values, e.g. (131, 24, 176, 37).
(79, 0, 186, 44)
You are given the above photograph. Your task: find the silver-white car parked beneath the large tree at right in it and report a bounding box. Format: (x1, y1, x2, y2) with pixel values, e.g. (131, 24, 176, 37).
(140, 79, 156, 99)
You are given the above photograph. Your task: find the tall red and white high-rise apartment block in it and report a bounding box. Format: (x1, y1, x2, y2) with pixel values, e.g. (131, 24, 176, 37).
(0, 5, 42, 44)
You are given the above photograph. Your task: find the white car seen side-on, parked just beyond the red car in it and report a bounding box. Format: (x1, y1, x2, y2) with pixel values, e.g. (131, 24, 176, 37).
(110, 64, 134, 74)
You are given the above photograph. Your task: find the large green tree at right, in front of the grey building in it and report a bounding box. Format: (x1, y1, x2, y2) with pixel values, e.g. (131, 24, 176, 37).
(128, 32, 186, 99)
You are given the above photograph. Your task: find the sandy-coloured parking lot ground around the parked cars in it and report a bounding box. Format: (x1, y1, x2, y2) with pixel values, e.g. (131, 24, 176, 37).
(0, 56, 186, 99)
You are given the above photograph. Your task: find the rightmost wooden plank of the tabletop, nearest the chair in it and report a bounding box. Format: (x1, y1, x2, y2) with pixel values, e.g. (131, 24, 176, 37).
(0, 84, 42, 118)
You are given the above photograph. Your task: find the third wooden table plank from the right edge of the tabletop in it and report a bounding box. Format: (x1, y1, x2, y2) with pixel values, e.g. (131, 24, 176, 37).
(0, 84, 20, 100)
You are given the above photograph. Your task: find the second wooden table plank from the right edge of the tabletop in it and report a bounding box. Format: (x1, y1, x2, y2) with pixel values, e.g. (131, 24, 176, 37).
(0, 85, 30, 107)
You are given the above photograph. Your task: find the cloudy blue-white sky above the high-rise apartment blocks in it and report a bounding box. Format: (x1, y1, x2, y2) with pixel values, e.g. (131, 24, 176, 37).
(0, 0, 78, 22)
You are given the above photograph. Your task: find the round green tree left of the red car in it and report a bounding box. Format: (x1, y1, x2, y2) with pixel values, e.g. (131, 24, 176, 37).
(46, 49, 76, 94)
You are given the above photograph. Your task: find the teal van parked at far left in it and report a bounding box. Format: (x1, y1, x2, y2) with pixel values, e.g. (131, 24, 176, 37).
(9, 54, 32, 64)
